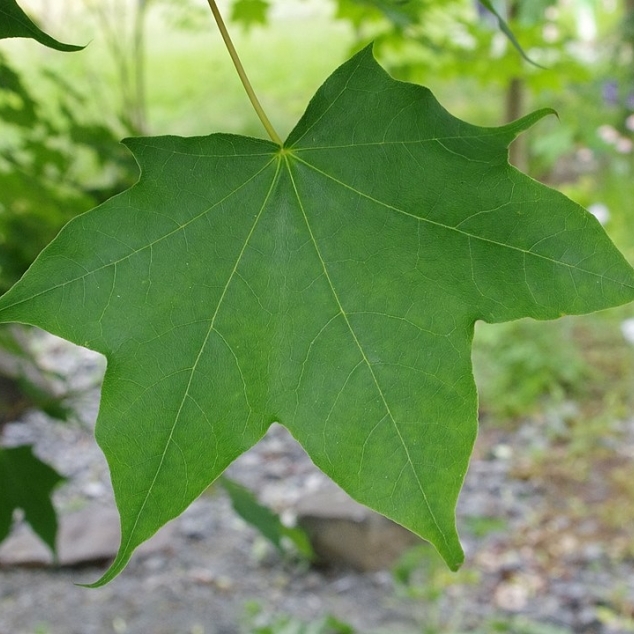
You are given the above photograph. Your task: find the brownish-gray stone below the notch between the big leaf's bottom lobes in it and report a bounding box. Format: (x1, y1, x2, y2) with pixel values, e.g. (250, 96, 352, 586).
(296, 484, 421, 572)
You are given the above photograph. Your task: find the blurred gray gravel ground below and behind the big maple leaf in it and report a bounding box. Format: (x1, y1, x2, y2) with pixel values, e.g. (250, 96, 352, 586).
(0, 339, 634, 634)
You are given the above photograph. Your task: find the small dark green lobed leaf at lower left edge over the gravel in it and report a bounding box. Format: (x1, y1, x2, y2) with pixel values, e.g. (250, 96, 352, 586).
(0, 445, 64, 553)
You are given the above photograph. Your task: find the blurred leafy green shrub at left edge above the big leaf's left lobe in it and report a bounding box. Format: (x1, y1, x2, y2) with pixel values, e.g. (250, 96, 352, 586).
(0, 55, 138, 293)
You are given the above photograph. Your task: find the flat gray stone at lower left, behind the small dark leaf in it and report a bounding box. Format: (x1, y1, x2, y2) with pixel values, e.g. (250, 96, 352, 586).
(0, 504, 173, 566)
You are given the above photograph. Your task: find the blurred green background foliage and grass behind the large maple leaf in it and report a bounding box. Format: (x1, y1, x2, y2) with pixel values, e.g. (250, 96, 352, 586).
(0, 0, 634, 596)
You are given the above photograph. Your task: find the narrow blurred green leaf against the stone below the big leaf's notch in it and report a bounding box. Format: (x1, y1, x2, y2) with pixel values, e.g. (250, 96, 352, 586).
(218, 476, 314, 559)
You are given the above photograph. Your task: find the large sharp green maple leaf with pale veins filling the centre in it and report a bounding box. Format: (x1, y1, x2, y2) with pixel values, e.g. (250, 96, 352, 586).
(0, 49, 634, 583)
